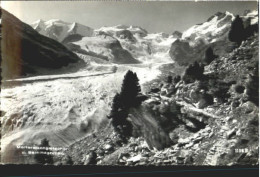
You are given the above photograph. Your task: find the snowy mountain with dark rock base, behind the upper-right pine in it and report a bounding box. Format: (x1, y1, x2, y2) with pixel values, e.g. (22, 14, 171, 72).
(169, 11, 258, 65)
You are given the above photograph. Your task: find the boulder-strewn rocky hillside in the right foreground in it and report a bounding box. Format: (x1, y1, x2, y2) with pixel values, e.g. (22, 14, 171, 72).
(60, 10, 259, 166)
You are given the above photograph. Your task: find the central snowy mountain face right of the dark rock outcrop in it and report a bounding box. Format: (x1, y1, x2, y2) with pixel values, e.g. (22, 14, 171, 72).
(95, 25, 178, 63)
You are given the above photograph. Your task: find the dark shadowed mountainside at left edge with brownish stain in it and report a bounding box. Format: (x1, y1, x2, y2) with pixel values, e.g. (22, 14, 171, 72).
(2, 9, 80, 78)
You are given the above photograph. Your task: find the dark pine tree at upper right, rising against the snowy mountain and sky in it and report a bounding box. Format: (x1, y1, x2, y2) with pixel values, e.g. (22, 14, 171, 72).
(228, 15, 245, 45)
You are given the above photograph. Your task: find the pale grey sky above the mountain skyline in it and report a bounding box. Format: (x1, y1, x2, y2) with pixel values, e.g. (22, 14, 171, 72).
(1, 1, 257, 34)
